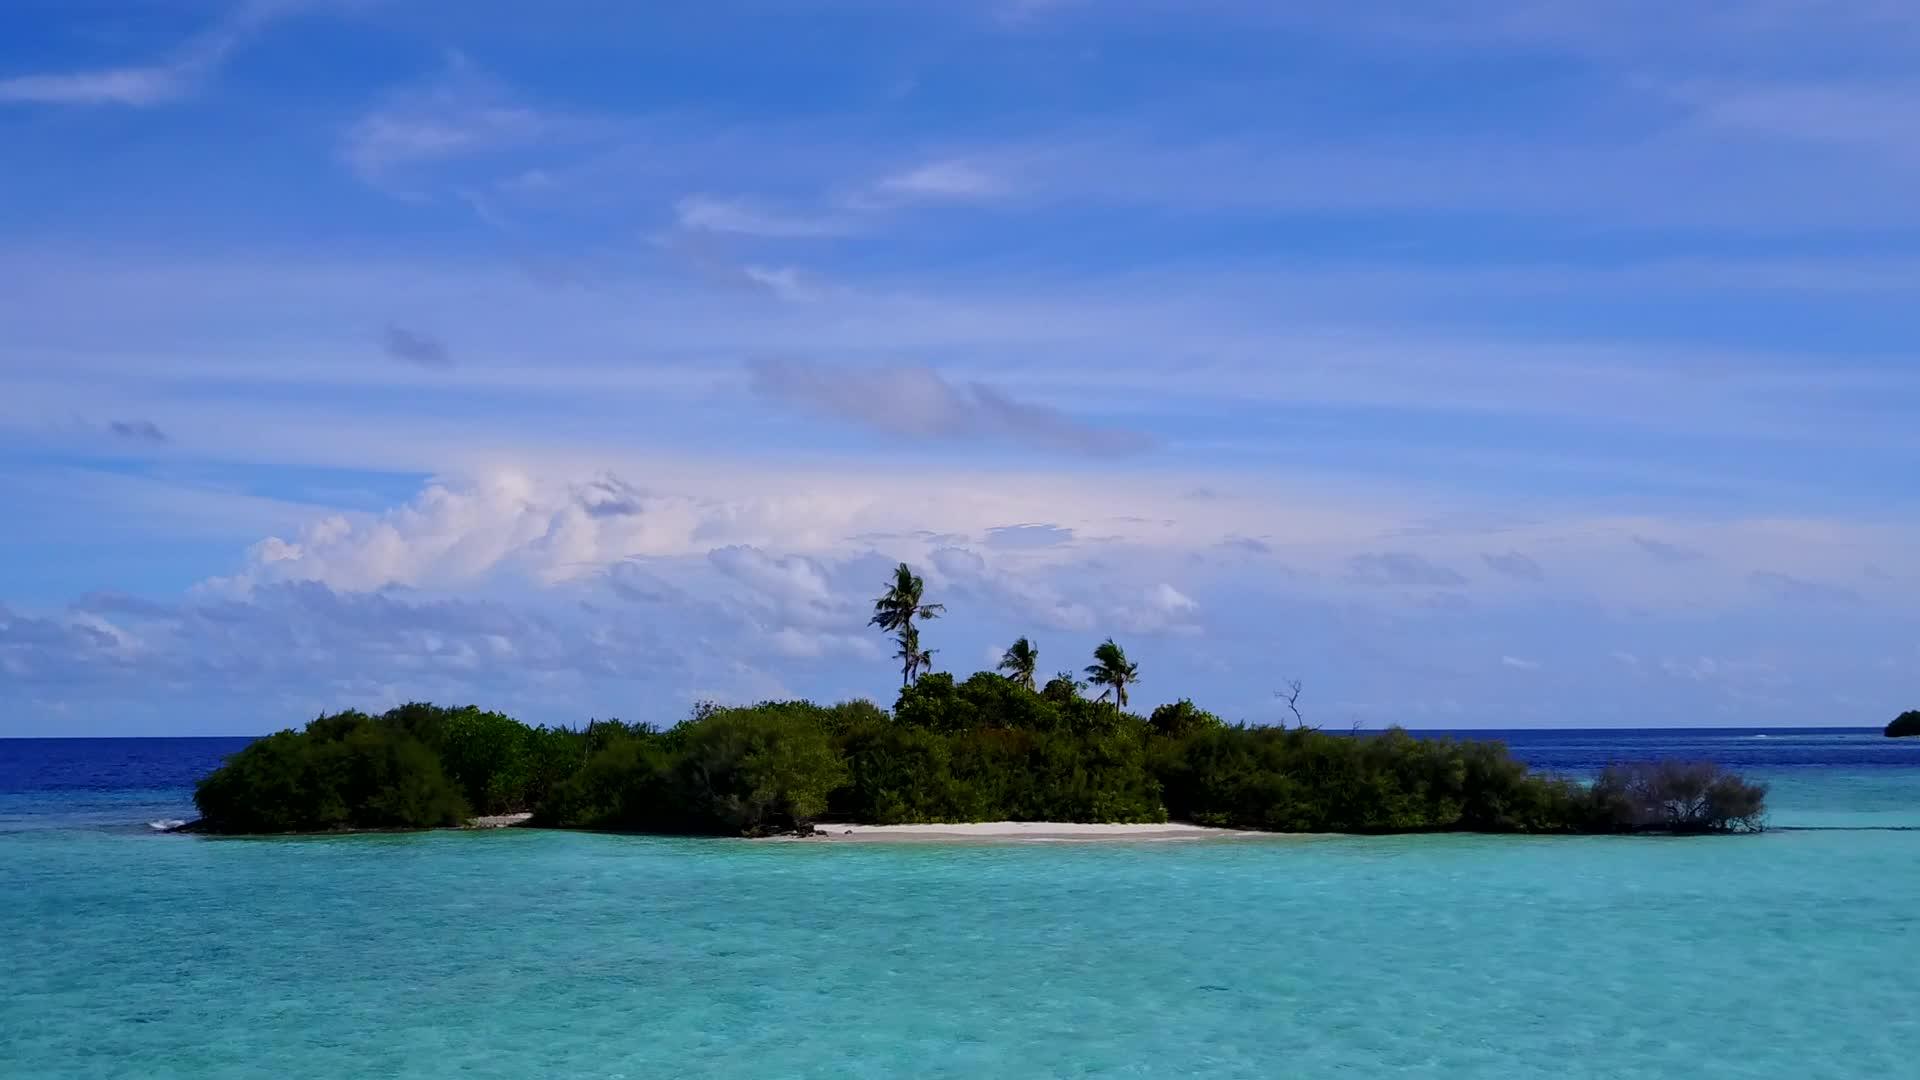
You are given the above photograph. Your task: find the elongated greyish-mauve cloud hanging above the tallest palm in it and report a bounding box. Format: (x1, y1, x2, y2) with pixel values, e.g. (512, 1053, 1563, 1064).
(749, 359, 1158, 454)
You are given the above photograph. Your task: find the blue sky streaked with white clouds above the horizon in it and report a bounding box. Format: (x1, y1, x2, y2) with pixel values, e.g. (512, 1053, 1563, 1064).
(0, 0, 1920, 736)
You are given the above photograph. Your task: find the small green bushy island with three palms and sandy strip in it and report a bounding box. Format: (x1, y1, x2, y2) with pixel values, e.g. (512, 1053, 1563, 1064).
(188, 563, 1766, 836)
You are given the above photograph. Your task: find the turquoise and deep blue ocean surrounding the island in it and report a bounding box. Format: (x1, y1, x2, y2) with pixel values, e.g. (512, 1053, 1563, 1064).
(0, 728, 1920, 1080)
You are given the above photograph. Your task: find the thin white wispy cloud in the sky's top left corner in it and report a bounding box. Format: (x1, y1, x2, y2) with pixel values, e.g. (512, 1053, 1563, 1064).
(0, 0, 305, 108)
